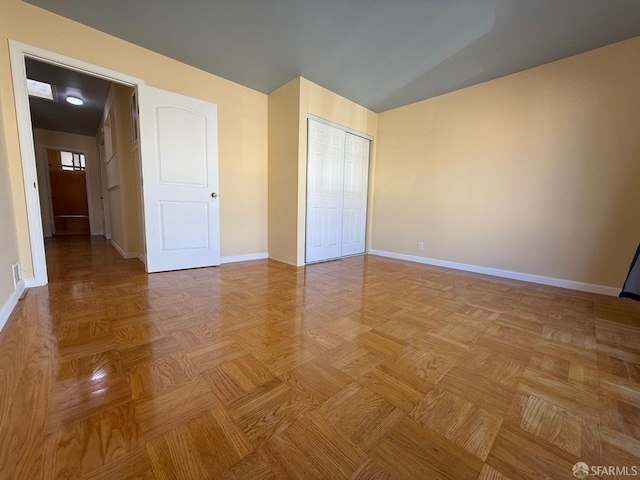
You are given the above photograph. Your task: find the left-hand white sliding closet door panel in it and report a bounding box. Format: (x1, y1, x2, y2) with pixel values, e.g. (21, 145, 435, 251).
(306, 120, 345, 262)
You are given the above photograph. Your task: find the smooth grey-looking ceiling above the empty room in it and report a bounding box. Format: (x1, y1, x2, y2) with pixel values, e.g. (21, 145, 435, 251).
(22, 0, 640, 112)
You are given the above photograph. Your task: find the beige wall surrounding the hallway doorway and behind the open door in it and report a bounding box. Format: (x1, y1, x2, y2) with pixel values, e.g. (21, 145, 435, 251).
(0, 0, 267, 276)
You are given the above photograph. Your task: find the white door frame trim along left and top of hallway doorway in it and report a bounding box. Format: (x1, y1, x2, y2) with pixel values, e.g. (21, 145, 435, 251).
(9, 40, 144, 287)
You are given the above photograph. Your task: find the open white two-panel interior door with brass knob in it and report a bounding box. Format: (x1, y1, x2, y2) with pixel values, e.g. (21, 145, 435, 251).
(138, 85, 220, 272)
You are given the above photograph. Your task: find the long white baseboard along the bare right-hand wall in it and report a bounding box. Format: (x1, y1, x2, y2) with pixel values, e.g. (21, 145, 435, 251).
(369, 249, 621, 297)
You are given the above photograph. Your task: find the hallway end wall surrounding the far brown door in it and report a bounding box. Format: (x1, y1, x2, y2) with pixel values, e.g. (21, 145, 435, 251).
(33, 128, 103, 236)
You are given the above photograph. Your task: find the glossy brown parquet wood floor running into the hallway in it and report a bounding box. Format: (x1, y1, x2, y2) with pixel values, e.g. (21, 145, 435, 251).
(0, 237, 640, 480)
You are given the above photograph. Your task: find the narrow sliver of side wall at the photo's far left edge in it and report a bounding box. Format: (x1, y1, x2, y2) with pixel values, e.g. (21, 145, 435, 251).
(0, 93, 19, 312)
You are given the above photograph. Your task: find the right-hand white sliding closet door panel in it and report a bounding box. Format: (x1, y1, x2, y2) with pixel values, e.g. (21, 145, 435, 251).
(342, 133, 369, 256)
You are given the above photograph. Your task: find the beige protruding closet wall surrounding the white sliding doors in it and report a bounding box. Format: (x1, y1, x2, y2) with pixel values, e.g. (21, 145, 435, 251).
(269, 77, 377, 266)
